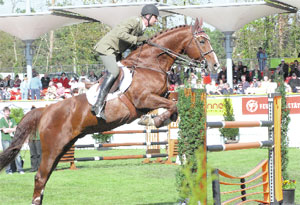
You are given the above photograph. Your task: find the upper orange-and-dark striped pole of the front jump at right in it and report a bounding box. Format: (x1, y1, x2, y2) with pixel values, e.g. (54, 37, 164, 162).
(207, 120, 273, 128)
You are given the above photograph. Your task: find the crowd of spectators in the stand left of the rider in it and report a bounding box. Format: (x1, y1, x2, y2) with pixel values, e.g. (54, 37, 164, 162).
(0, 71, 102, 100)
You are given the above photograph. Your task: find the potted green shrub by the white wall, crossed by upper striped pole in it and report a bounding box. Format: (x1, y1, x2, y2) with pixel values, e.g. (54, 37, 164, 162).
(219, 97, 240, 144)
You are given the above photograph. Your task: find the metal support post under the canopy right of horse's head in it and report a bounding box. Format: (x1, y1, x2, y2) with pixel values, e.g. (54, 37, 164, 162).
(224, 31, 233, 88)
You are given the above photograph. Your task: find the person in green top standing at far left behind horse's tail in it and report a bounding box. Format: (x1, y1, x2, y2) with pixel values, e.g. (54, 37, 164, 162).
(0, 107, 24, 174)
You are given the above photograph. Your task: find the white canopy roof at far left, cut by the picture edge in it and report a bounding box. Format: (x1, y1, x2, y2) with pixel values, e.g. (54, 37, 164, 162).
(0, 12, 87, 40)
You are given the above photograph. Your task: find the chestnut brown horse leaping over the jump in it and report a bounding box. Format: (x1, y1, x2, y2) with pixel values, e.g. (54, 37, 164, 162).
(0, 19, 219, 205)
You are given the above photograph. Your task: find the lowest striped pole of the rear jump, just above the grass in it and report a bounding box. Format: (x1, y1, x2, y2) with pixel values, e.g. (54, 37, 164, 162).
(74, 154, 168, 162)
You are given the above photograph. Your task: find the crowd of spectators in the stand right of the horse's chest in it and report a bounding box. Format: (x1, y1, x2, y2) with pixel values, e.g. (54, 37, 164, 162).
(169, 57, 300, 95)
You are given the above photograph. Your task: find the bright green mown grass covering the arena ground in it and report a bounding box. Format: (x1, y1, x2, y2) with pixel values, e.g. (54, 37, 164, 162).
(0, 149, 300, 205)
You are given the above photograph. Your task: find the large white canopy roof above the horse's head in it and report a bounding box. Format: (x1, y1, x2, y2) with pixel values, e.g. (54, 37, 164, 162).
(161, 0, 292, 32)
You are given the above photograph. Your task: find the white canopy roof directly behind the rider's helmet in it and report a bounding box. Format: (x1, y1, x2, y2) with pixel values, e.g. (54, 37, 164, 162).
(49, 2, 169, 27)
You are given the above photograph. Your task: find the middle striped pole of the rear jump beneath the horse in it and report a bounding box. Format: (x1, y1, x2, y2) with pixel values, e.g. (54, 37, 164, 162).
(75, 141, 168, 148)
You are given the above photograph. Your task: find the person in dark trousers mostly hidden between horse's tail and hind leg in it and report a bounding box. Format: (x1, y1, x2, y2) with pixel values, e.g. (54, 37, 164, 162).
(28, 106, 42, 172)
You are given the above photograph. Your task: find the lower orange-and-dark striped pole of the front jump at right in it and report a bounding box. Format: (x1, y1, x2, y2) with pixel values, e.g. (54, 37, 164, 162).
(207, 141, 274, 152)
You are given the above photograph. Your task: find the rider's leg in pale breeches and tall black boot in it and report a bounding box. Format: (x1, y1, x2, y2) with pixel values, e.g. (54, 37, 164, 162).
(92, 55, 120, 117)
